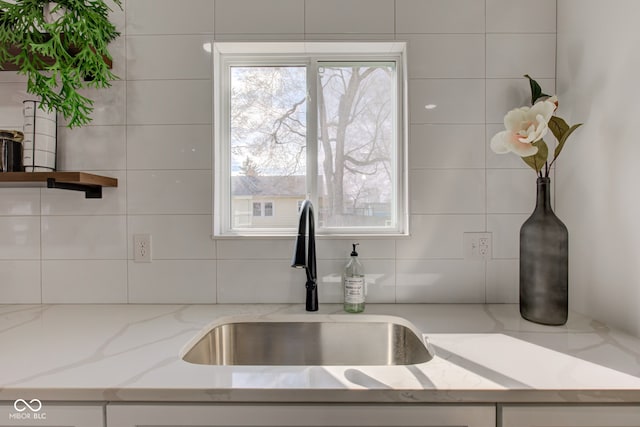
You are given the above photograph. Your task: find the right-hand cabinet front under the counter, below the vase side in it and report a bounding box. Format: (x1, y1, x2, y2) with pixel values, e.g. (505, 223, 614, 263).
(502, 405, 640, 427)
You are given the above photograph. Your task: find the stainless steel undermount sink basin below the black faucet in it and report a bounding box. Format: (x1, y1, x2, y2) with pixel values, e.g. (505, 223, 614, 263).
(182, 315, 433, 366)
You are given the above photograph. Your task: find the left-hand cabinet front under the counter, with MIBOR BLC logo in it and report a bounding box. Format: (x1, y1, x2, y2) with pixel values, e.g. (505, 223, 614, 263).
(0, 399, 104, 427)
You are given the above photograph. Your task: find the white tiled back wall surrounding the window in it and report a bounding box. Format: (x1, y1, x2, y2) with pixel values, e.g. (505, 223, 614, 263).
(0, 0, 556, 303)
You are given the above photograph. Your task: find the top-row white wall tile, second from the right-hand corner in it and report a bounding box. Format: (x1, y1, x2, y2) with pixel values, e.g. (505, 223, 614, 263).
(396, 0, 485, 34)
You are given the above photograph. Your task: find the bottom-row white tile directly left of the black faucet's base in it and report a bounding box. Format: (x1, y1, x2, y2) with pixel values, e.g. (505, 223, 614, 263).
(217, 259, 306, 305)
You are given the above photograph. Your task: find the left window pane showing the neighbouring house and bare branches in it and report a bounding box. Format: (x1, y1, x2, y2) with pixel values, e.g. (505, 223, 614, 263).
(230, 66, 307, 228)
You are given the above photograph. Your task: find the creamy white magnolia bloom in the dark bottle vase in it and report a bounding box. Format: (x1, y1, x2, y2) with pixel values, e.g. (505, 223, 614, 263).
(491, 100, 556, 157)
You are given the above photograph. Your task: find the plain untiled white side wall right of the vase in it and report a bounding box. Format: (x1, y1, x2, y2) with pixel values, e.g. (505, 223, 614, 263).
(556, 0, 640, 335)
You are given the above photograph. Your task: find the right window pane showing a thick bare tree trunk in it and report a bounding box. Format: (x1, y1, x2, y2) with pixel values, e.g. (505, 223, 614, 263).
(318, 62, 396, 227)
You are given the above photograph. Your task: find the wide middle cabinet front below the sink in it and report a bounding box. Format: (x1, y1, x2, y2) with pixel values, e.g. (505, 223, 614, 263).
(107, 404, 496, 427)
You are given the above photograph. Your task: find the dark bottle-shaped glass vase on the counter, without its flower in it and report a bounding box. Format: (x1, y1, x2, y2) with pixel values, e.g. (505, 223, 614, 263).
(520, 178, 569, 325)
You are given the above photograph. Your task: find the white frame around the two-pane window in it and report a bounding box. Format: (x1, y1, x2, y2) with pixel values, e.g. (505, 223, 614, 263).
(212, 41, 409, 237)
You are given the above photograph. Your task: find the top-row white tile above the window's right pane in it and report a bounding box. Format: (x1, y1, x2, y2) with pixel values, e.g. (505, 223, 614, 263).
(304, 0, 394, 34)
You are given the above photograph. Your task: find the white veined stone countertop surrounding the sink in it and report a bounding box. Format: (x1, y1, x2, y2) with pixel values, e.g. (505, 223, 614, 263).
(0, 304, 640, 403)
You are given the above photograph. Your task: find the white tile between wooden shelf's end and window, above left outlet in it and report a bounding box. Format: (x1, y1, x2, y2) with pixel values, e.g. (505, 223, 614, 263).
(127, 170, 212, 214)
